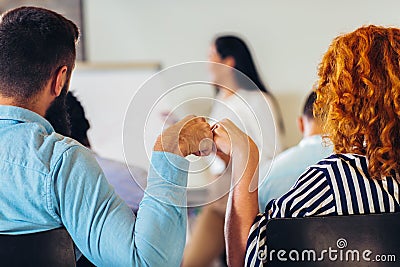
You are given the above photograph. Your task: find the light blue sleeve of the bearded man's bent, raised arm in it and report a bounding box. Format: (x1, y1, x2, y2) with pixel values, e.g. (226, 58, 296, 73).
(51, 146, 189, 266)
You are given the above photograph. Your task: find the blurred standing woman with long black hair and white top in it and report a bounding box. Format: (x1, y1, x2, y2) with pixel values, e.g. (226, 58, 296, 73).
(182, 35, 284, 267)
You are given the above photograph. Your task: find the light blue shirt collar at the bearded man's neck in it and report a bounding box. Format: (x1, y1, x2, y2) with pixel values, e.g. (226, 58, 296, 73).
(0, 105, 54, 134)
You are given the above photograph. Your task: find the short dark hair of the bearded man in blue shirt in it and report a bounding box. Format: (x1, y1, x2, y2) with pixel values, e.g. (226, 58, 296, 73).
(0, 7, 79, 102)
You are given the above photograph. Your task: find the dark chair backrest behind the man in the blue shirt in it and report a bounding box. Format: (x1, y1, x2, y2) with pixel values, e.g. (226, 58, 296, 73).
(0, 228, 76, 267)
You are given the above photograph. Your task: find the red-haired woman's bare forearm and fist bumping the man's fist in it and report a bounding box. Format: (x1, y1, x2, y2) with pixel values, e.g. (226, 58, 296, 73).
(212, 120, 259, 267)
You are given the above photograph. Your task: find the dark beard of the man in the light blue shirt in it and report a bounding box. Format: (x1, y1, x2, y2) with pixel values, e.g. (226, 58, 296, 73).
(45, 83, 71, 136)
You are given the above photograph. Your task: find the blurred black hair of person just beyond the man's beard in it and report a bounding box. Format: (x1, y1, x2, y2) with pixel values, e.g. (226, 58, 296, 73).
(66, 92, 90, 147)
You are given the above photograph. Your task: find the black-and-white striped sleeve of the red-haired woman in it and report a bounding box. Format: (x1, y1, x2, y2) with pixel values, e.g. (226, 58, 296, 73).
(245, 168, 336, 266)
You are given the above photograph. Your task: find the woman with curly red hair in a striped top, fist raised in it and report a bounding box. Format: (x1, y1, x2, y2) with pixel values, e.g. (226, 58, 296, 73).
(214, 25, 400, 266)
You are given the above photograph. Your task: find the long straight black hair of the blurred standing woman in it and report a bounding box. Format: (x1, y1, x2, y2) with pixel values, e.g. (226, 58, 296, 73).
(214, 35, 285, 133)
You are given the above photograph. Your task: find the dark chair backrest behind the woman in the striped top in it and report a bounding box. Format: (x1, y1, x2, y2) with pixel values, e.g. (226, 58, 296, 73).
(258, 213, 400, 267)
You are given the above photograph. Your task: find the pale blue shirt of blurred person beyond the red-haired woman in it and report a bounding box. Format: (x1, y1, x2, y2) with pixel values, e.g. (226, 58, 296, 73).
(258, 135, 332, 213)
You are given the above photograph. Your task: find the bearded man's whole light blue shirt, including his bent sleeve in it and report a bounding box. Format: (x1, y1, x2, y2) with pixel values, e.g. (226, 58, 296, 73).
(0, 106, 189, 266)
